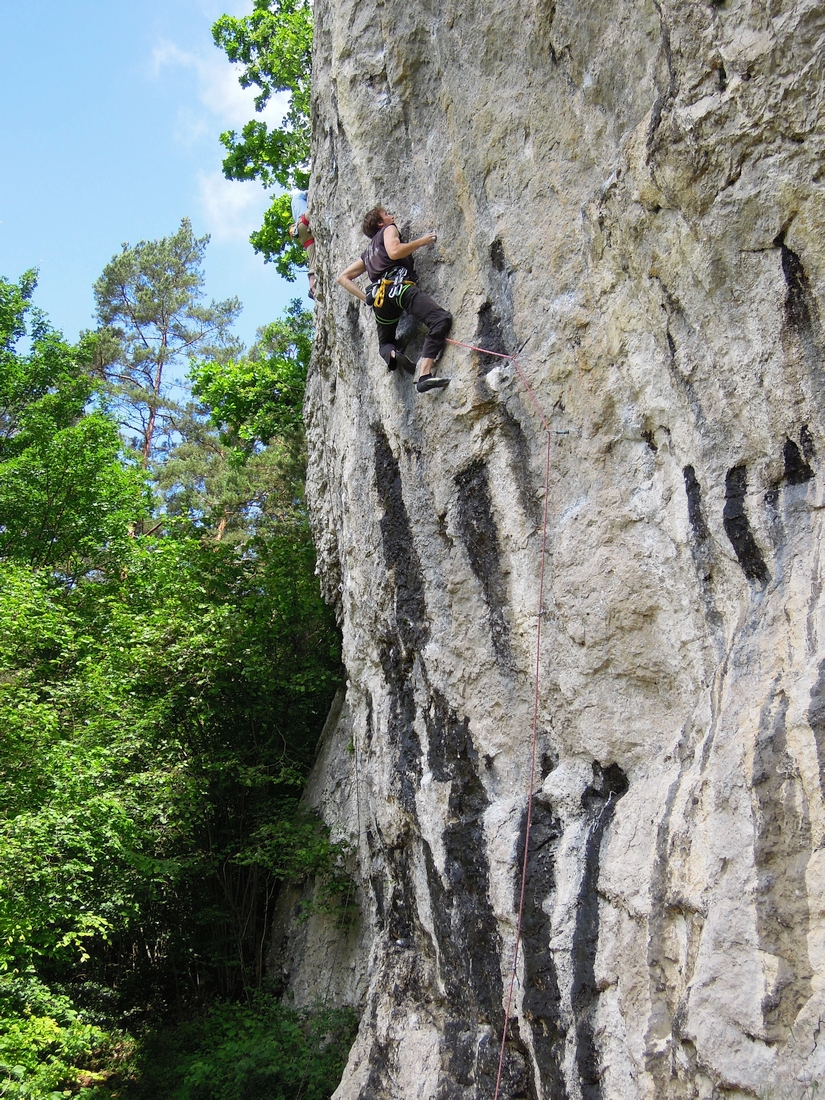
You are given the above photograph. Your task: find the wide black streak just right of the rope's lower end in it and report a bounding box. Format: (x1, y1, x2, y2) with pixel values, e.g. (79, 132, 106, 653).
(515, 801, 568, 1100)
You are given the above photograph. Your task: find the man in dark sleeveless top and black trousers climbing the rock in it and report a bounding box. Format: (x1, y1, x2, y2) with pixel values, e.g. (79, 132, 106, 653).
(338, 206, 452, 394)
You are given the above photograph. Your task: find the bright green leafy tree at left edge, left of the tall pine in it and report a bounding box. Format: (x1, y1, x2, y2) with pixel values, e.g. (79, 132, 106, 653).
(0, 272, 144, 575)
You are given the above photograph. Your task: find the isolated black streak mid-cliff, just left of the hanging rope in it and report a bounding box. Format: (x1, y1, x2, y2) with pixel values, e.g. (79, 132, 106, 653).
(455, 460, 510, 663)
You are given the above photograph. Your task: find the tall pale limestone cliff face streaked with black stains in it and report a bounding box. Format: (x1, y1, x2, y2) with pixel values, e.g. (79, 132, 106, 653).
(287, 0, 825, 1100)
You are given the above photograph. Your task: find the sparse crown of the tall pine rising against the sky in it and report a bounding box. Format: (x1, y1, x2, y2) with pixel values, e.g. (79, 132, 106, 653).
(95, 218, 241, 465)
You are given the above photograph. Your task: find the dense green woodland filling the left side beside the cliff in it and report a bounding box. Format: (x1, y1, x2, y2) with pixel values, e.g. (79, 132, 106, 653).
(0, 277, 351, 1100)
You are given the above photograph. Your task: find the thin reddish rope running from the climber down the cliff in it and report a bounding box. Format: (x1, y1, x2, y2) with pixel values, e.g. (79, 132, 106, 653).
(447, 338, 556, 1100)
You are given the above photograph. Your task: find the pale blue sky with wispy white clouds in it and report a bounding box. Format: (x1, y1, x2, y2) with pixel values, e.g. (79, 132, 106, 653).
(0, 0, 307, 344)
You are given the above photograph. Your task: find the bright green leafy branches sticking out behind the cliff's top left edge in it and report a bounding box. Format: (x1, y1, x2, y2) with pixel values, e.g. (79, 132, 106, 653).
(212, 0, 312, 278)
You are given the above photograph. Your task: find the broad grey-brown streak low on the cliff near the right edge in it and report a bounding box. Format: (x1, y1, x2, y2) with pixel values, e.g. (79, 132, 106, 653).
(752, 692, 811, 1043)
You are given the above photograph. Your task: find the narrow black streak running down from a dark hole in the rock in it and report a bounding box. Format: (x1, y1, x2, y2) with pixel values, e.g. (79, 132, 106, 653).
(571, 761, 628, 1100)
